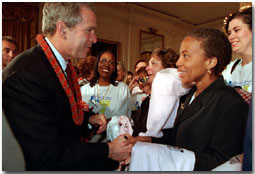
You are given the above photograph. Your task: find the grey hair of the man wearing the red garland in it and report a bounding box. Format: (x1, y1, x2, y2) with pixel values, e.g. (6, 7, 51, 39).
(42, 2, 96, 35)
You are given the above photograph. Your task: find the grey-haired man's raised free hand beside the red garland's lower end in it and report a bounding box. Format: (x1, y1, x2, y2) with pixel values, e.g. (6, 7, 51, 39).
(89, 114, 107, 134)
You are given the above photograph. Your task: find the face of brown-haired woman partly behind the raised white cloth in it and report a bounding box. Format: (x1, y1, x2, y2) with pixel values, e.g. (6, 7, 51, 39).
(146, 55, 164, 84)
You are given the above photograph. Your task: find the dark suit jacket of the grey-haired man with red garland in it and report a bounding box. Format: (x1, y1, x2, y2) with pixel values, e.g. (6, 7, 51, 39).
(2, 46, 109, 170)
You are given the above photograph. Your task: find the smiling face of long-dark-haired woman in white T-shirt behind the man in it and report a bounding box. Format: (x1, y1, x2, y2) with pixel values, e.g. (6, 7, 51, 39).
(98, 52, 115, 79)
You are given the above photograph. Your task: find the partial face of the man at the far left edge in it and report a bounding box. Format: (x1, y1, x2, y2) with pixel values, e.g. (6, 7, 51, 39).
(2, 40, 18, 69)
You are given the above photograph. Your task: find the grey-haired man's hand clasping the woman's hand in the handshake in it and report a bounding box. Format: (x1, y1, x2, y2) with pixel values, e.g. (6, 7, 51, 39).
(108, 134, 133, 161)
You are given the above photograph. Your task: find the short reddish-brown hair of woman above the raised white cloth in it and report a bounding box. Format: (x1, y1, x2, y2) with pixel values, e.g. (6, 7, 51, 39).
(151, 48, 179, 68)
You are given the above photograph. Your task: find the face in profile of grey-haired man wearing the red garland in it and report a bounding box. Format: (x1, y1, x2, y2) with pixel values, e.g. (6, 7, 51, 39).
(63, 7, 97, 59)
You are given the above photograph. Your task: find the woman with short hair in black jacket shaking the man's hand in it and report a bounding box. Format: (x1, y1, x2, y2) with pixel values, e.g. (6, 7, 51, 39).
(125, 28, 248, 171)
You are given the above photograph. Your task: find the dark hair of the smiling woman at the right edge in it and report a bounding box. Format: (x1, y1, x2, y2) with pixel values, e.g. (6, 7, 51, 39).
(224, 7, 252, 34)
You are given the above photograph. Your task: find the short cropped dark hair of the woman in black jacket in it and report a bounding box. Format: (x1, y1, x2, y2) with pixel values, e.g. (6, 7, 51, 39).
(186, 28, 232, 76)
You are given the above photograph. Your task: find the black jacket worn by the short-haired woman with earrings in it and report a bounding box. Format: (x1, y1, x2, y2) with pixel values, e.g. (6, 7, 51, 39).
(153, 77, 248, 171)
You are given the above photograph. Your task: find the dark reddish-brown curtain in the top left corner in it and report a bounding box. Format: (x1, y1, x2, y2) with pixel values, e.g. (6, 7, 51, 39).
(2, 2, 39, 52)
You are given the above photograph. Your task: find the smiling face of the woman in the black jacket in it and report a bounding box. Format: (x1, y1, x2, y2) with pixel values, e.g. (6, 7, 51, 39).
(176, 36, 208, 84)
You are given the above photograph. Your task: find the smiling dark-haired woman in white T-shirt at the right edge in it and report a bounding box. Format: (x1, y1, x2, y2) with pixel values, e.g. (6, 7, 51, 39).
(222, 7, 252, 92)
